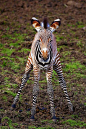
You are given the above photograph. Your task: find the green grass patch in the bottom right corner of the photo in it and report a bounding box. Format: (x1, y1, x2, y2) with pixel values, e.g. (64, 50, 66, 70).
(62, 119, 86, 128)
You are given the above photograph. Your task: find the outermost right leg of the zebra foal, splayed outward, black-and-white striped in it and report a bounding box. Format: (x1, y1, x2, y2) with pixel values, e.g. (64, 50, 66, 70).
(54, 53, 73, 111)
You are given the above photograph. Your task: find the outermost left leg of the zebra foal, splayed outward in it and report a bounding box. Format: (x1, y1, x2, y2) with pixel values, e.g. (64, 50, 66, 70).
(11, 55, 32, 110)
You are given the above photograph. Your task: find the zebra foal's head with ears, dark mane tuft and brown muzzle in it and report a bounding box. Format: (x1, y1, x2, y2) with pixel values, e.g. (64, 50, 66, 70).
(31, 17, 61, 66)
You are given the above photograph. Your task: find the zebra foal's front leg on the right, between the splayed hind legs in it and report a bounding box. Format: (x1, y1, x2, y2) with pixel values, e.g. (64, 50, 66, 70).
(46, 67, 56, 119)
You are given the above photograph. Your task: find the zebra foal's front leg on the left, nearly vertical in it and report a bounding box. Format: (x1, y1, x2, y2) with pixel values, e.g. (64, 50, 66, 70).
(30, 65, 40, 120)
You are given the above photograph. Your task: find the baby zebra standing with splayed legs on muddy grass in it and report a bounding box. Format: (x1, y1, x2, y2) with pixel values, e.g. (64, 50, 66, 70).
(12, 17, 73, 120)
